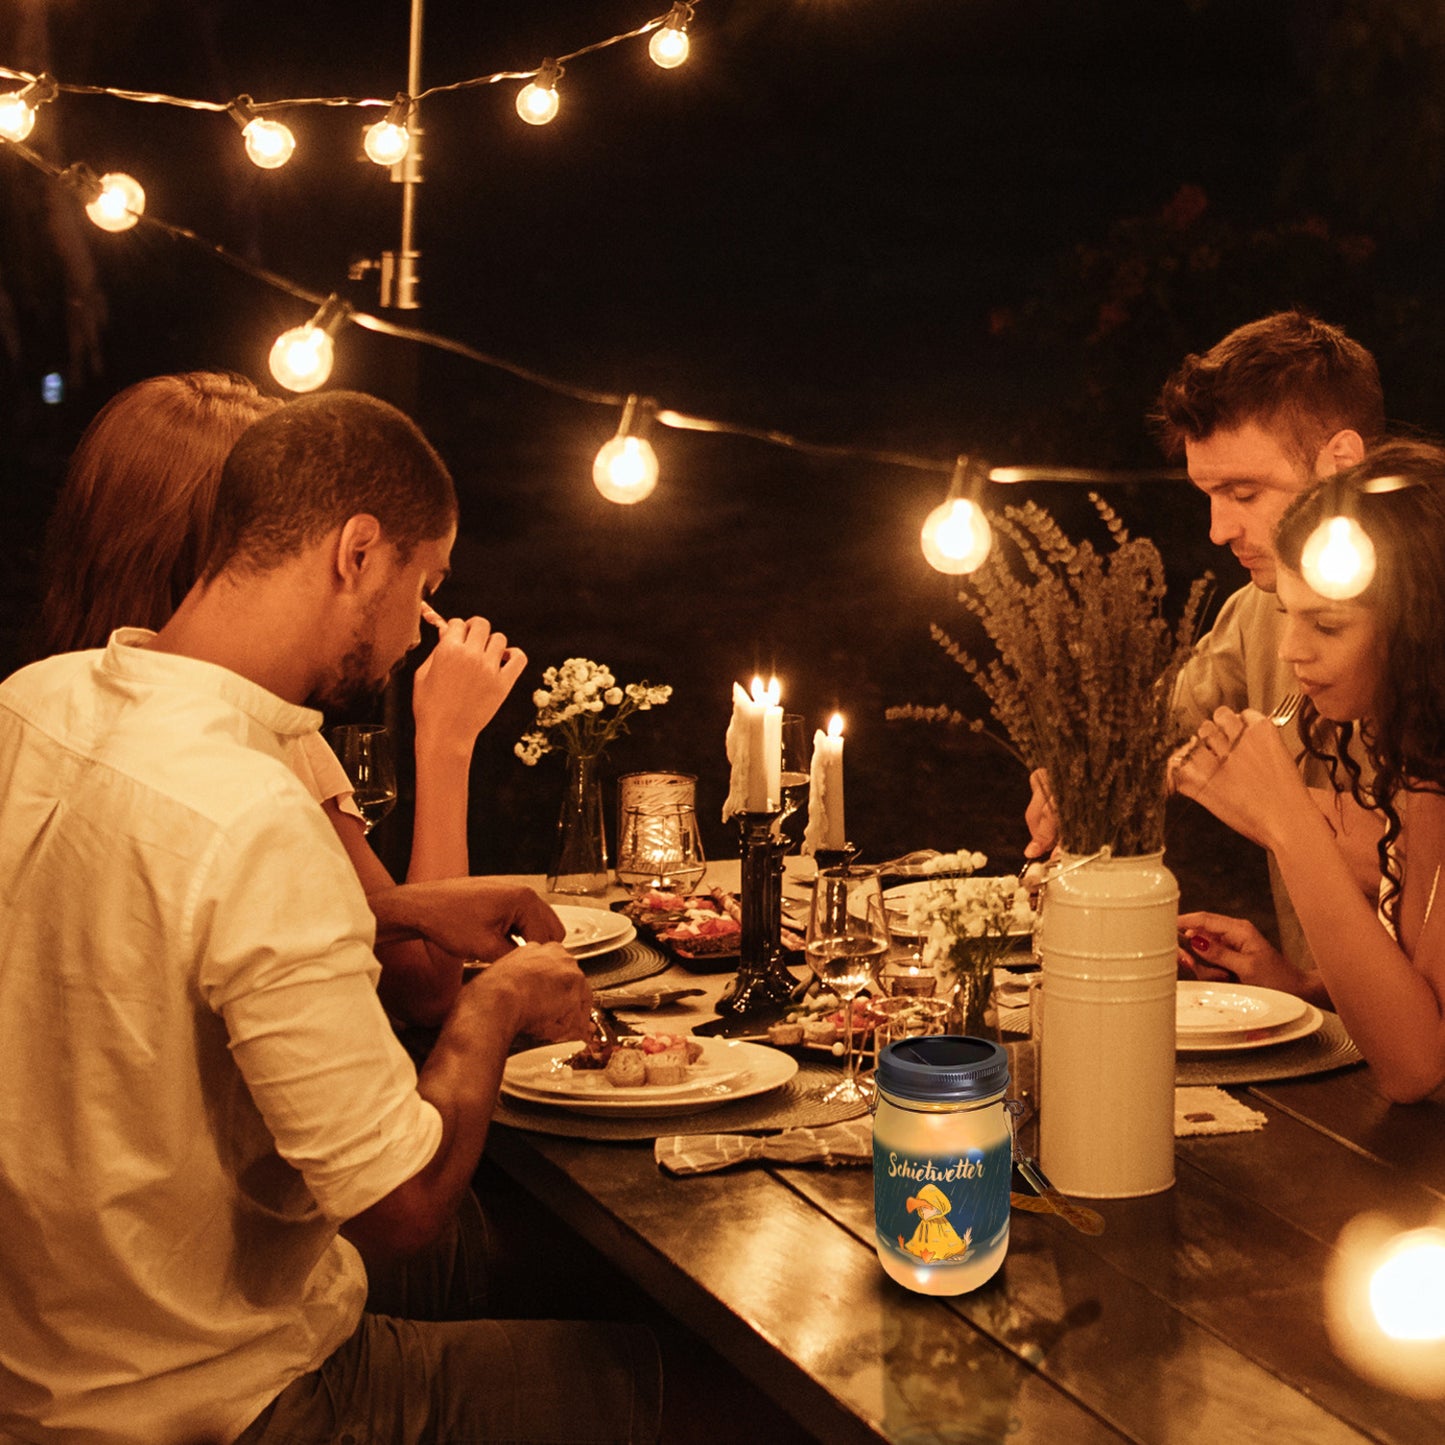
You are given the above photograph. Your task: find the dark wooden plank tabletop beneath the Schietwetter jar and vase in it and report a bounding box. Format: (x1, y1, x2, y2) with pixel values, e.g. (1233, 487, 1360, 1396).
(487, 861, 1445, 1445)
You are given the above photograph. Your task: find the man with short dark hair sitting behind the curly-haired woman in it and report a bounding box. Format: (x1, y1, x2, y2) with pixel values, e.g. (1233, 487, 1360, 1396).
(1027, 311, 1384, 967)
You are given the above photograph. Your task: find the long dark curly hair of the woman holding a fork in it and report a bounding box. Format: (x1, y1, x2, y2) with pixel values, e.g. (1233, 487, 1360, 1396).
(1274, 441, 1445, 922)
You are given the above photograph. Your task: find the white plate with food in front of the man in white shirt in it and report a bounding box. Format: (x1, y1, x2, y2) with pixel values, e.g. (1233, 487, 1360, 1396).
(501, 1039, 798, 1117)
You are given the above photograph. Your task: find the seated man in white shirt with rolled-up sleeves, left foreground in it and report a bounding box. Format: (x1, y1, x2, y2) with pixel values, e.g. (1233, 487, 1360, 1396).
(0, 393, 660, 1442)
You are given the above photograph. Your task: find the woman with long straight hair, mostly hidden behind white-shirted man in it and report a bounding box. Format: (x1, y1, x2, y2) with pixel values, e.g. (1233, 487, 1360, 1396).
(40, 371, 531, 1025)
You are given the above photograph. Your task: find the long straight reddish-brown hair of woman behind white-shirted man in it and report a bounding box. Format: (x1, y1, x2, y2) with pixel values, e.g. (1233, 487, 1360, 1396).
(39, 371, 282, 653)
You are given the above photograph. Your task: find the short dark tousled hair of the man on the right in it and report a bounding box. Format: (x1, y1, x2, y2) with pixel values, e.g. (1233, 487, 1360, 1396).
(1150, 311, 1384, 465)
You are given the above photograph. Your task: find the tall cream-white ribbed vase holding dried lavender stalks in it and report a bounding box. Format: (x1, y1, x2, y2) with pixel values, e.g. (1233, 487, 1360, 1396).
(1039, 853, 1179, 1199)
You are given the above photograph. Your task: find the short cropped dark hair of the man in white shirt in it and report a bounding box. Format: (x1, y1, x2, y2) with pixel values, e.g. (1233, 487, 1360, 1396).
(205, 392, 457, 578)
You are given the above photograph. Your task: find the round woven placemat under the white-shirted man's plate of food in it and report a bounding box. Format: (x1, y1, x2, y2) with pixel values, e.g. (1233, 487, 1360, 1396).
(491, 1062, 866, 1140)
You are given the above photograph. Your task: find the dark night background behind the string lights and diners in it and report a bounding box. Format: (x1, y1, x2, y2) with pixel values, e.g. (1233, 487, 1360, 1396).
(0, 0, 1445, 912)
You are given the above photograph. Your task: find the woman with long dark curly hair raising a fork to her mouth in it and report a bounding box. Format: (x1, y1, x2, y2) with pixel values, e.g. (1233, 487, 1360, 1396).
(1175, 441, 1445, 1103)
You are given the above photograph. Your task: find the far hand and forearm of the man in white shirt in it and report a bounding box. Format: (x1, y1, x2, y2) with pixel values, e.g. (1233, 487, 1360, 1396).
(368, 879, 566, 962)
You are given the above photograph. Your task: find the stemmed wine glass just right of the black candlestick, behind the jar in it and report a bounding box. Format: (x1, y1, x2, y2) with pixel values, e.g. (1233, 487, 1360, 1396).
(805, 867, 889, 1104)
